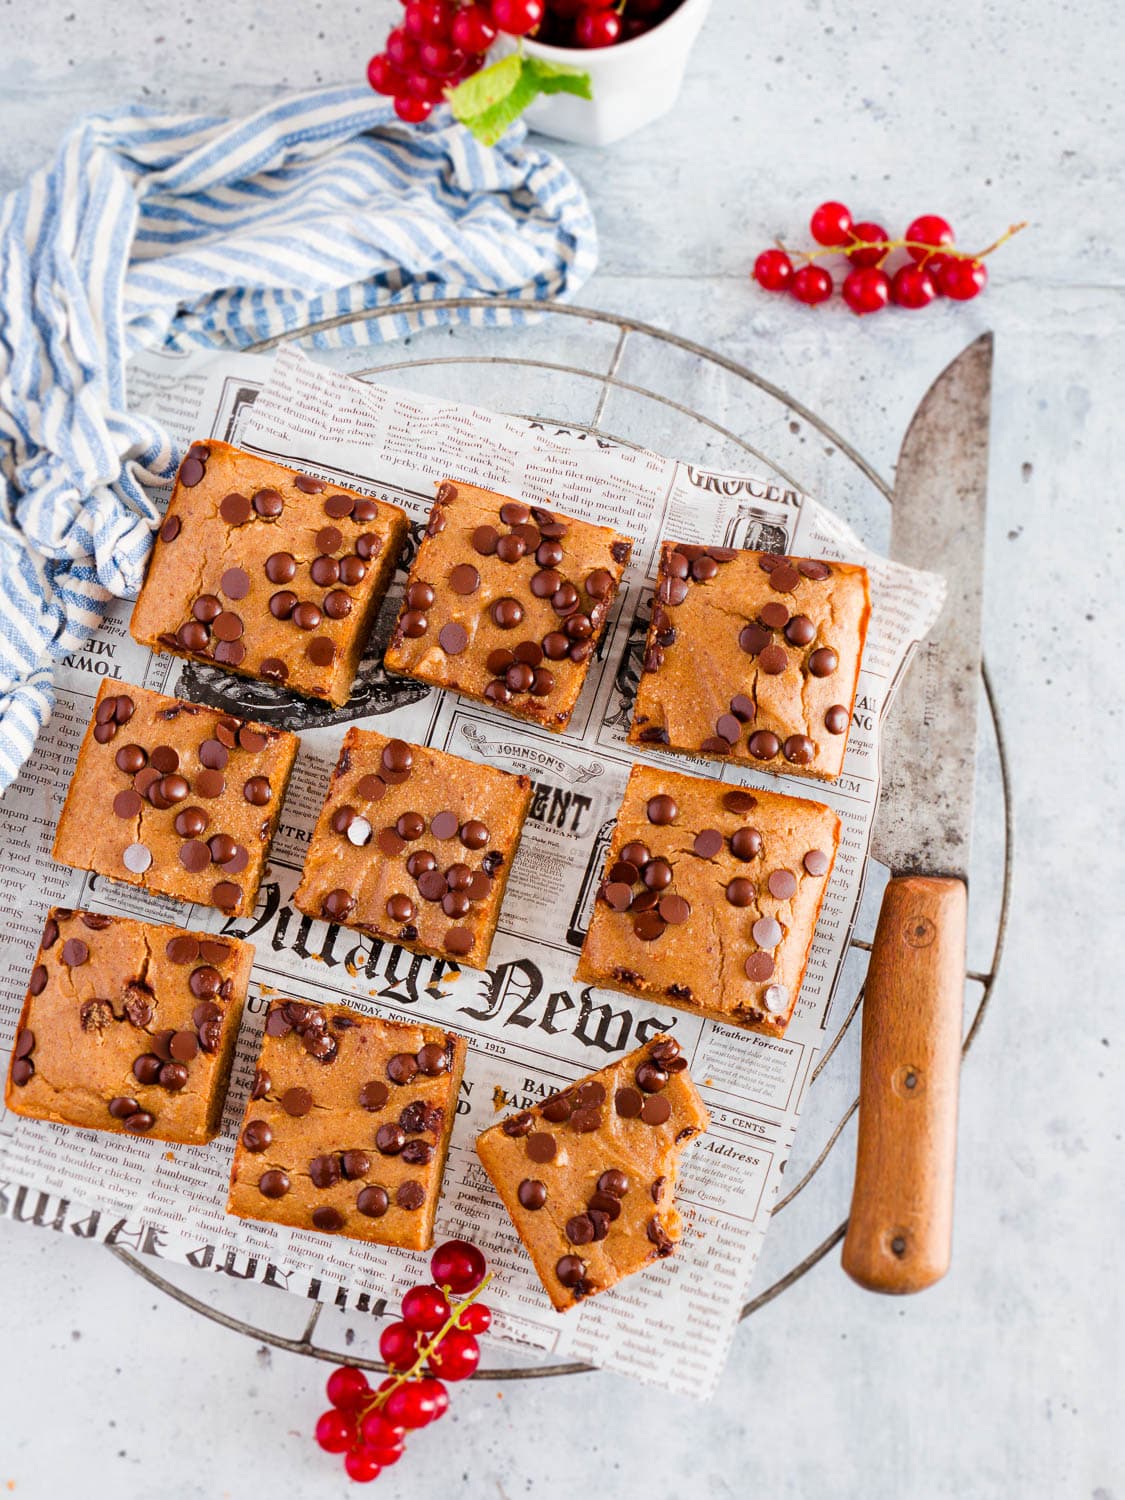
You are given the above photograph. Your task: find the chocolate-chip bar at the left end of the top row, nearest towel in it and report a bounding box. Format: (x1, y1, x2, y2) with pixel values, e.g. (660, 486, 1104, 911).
(129, 438, 407, 705)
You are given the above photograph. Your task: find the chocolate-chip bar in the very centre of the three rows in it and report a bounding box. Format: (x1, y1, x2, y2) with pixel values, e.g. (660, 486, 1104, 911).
(294, 729, 531, 969)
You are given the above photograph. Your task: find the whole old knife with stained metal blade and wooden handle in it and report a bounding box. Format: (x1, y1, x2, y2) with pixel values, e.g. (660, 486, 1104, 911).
(842, 333, 993, 1293)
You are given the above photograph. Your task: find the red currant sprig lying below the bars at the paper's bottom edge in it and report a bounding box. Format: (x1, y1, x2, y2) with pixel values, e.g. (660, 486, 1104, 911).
(317, 1239, 492, 1484)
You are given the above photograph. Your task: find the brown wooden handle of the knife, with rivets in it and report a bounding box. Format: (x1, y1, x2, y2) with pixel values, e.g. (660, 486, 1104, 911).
(843, 876, 968, 1293)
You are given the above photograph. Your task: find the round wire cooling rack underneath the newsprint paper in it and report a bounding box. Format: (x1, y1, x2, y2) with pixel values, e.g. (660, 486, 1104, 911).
(113, 299, 1013, 1380)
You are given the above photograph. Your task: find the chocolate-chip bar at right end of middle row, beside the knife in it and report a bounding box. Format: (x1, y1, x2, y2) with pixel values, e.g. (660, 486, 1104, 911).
(576, 765, 840, 1037)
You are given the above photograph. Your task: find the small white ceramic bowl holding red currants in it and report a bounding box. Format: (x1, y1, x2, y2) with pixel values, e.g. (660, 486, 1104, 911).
(509, 0, 711, 146)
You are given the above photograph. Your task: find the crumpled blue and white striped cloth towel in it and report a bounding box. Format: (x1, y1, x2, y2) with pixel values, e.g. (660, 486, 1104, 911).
(0, 87, 597, 791)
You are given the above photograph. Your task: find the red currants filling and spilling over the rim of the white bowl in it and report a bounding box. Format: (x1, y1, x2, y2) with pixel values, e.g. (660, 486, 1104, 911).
(368, 0, 680, 125)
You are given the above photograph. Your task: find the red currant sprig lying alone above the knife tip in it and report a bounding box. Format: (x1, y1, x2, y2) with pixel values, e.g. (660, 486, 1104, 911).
(755, 203, 1025, 317)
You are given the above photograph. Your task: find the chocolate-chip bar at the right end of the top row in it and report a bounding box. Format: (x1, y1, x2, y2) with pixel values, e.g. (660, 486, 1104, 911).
(629, 542, 870, 780)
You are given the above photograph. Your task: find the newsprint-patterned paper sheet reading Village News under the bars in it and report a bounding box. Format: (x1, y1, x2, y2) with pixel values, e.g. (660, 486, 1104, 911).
(0, 350, 944, 1397)
